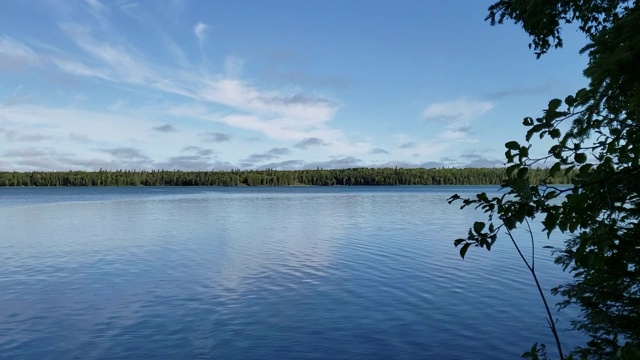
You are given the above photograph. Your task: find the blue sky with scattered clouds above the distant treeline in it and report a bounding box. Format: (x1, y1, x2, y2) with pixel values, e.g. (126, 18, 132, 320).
(0, 0, 587, 171)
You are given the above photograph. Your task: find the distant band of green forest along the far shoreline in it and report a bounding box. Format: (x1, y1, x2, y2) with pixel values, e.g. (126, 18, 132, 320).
(0, 168, 574, 187)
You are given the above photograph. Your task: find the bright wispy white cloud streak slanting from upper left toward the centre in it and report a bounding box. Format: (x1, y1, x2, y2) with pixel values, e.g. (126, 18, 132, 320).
(52, 24, 344, 140)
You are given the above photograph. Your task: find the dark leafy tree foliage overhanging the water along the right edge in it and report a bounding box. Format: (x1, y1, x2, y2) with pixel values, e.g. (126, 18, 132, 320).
(450, 0, 640, 359)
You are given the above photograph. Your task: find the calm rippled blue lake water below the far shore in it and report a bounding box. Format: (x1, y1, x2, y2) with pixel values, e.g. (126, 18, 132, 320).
(0, 187, 581, 359)
